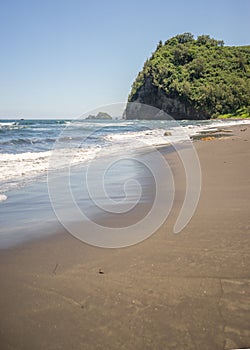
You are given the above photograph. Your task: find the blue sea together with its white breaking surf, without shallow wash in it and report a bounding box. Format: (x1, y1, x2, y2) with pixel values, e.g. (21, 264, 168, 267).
(0, 119, 249, 194)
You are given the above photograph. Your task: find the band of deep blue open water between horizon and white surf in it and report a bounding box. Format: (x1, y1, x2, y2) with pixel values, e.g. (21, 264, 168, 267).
(0, 119, 221, 154)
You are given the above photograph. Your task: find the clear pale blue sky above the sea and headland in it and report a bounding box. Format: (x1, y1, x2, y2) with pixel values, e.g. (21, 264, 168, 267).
(0, 0, 250, 119)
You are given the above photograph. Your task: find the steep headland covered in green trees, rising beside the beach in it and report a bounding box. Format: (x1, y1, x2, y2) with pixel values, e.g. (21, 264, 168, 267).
(124, 33, 250, 119)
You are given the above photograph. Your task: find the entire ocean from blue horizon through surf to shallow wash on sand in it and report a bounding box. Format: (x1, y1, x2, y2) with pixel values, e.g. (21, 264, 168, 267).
(0, 119, 250, 248)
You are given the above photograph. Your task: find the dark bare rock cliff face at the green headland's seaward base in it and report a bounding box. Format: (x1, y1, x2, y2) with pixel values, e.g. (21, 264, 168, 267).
(125, 77, 209, 120)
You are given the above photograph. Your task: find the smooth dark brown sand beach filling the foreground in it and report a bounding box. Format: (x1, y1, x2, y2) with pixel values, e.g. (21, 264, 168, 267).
(0, 125, 250, 350)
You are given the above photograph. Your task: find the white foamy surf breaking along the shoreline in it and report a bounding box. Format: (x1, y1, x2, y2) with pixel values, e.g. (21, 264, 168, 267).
(0, 120, 250, 193)
